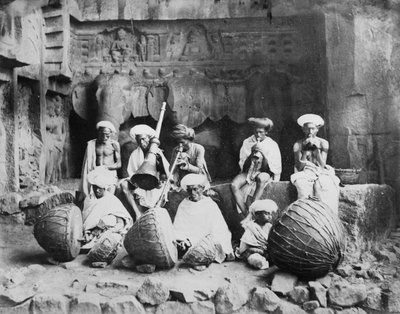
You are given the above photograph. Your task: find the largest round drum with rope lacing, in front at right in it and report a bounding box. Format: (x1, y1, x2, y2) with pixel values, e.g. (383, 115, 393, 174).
(268, 198, 345, 278)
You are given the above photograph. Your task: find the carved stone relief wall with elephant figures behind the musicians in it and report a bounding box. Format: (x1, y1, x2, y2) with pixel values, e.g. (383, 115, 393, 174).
(70, 14, 326, 177)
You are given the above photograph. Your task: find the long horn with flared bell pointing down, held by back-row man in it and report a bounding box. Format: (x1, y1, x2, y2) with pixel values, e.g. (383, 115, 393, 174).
(130, 101, 168, 190)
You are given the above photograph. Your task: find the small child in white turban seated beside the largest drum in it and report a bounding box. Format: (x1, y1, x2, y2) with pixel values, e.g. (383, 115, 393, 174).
(238, 199, 278, 269)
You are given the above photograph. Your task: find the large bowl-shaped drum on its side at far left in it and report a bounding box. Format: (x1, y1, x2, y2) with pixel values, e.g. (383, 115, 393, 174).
(33, 204, 83, 262)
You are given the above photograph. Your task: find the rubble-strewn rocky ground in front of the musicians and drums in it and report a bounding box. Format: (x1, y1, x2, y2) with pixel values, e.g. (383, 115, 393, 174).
(0, 182, 400, 314)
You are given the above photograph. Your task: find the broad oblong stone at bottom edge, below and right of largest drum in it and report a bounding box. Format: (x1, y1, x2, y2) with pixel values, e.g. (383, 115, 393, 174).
(328, 281, 367, 307)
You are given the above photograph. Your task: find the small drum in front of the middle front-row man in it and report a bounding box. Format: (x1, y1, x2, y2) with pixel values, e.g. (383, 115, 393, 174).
(182, 234, 217, 266)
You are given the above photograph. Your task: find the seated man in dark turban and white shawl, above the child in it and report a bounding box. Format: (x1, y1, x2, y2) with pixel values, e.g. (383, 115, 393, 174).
(231, 118, 282, 218)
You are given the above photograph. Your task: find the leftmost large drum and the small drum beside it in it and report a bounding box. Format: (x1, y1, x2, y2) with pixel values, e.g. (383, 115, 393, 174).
(33, 203, 122, 264)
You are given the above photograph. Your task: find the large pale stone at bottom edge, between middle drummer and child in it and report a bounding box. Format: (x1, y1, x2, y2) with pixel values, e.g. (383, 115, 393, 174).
(214, 283, 248, 314)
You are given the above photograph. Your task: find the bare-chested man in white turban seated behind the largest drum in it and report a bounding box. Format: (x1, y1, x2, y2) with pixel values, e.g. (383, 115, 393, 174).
(290, 114, 340, 213)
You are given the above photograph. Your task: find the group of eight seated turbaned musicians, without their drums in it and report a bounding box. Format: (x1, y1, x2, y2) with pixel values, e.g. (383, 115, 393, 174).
(76, 114, 339, 268)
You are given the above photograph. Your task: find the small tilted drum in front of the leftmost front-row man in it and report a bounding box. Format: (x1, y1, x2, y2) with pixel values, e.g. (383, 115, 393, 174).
(87, 231, 122, 264)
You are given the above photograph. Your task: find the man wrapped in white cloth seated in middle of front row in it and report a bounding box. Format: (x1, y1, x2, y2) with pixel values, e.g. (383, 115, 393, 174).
(174, 174, 233, 259)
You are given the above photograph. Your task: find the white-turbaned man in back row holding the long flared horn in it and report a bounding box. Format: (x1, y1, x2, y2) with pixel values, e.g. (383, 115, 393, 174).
(121, 124, 169, 220)
